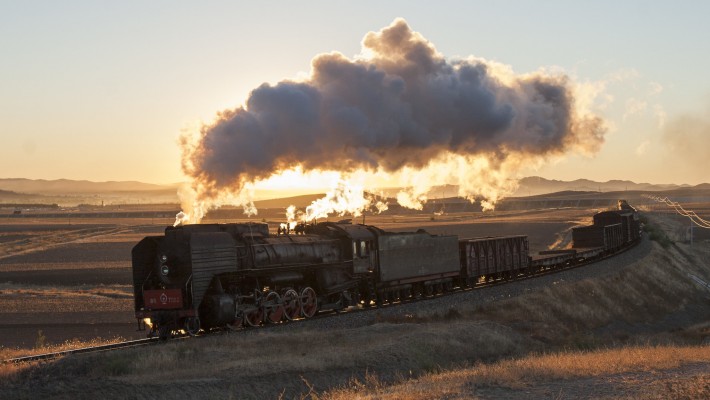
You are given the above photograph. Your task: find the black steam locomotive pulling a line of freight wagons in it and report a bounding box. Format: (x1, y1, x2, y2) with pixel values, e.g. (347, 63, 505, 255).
(132, 202, 640, 338)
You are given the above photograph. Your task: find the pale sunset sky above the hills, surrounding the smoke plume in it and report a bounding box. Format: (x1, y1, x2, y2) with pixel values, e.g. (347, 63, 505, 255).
(0, 0, 710, 184)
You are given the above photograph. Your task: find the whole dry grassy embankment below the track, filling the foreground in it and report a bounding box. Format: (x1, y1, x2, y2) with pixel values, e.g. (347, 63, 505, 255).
(0, 211, 710, 399)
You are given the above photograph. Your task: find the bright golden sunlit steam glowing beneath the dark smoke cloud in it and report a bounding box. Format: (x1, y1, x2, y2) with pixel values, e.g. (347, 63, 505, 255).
(175, 152, 535, 228)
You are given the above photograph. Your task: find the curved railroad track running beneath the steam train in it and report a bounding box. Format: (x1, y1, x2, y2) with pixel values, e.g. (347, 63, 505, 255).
(0, 240, 640, 364)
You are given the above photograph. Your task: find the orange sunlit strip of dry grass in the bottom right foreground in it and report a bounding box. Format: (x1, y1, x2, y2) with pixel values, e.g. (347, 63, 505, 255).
(324, 346, 710, 400)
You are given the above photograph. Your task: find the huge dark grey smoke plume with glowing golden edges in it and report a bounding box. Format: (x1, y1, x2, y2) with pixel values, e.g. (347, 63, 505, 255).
(181, 19, 605, 220)
